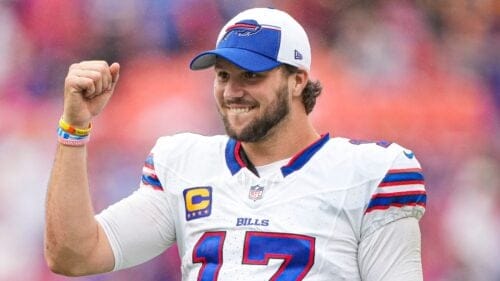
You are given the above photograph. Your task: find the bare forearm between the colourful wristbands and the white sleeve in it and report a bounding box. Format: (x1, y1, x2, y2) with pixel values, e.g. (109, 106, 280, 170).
(45, 144, 112, 275)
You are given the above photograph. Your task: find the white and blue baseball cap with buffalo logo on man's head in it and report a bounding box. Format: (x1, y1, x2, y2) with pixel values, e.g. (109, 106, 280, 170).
(190, 8, 311, 72)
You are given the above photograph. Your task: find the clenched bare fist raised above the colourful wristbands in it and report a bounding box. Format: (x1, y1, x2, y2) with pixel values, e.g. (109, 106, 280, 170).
(63, 60, 120, 128)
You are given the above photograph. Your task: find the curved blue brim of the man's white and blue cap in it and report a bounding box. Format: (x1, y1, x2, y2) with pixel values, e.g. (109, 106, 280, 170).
(189, 48, 281, 72)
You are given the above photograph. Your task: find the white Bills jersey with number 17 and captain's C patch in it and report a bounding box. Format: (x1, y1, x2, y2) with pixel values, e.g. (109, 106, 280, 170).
(97, 134, 426, 281)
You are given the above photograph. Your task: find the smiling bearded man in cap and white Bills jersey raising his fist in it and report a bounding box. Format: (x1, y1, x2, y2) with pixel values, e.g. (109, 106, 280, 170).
(45, 8, 426, 280)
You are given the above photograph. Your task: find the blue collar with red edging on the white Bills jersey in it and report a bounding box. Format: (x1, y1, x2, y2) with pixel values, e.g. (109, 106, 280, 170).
(225, 133, 330, 177)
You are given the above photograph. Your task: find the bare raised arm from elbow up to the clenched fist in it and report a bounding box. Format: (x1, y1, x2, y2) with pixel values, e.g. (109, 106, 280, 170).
(44, 61, 120, 276)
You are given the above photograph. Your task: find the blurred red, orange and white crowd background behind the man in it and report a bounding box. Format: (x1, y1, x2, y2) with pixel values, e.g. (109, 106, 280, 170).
(0, 0, 500, 281)
